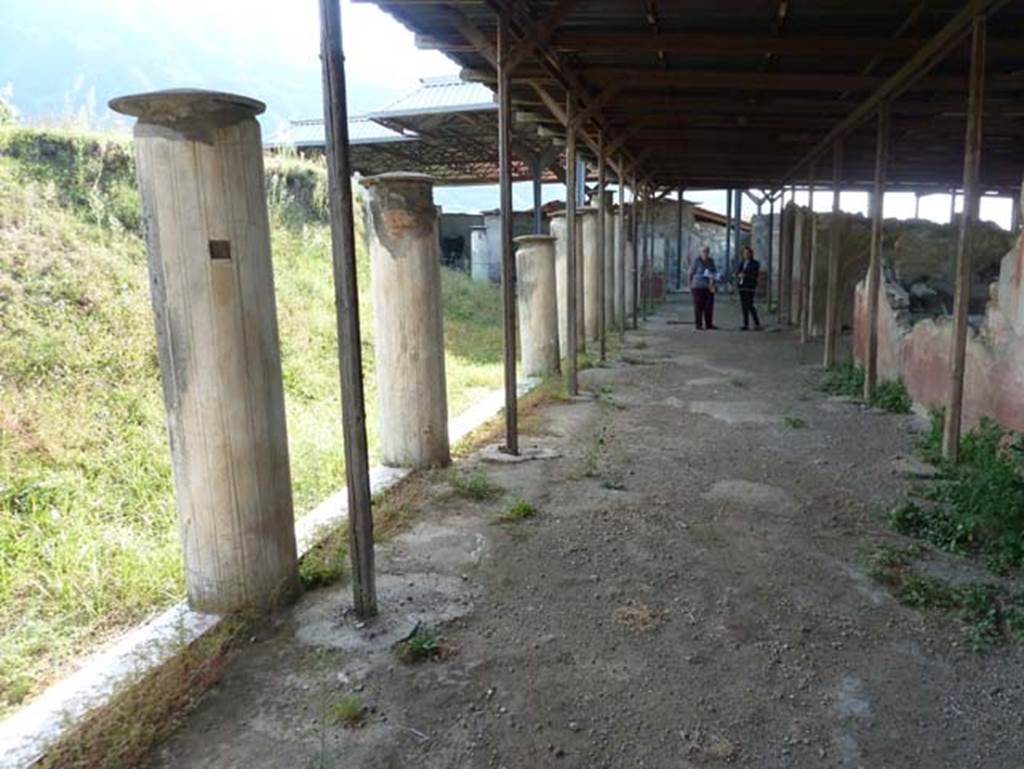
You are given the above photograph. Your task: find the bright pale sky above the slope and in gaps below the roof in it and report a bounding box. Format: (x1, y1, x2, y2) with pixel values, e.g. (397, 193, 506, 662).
(0, 0, 1011, 227)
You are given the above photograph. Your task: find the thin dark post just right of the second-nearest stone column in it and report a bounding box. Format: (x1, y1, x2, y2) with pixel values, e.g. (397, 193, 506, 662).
(498, 13, 519, 454)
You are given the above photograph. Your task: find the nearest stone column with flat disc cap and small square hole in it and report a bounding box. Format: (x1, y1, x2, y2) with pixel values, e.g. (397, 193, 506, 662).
(111, 90, 298, 612)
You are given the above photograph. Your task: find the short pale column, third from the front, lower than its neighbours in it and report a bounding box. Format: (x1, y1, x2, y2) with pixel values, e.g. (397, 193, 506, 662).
(515, 234, 564, 377)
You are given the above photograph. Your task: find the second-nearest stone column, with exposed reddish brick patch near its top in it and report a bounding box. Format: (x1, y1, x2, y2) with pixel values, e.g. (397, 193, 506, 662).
(362, 173, 450, 467)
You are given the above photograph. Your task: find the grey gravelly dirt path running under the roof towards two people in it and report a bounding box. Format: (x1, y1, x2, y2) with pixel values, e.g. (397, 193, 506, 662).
(151, 302, 1024, 769)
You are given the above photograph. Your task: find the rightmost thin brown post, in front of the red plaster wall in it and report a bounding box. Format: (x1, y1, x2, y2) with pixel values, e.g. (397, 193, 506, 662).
(942, 13, 986, 462)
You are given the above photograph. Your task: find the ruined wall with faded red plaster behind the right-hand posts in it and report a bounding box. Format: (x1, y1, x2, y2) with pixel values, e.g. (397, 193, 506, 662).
(854, 231, 1024, 431)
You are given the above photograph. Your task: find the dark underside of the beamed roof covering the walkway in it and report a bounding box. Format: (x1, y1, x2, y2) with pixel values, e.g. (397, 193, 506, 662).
(360, 0, 1024, 190)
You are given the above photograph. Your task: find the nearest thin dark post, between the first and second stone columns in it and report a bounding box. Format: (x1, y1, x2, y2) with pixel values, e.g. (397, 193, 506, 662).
(319, 0, 377, 618)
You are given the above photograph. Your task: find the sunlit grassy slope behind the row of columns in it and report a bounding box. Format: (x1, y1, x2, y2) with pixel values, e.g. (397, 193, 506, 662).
(0, 132, 501, 713)
